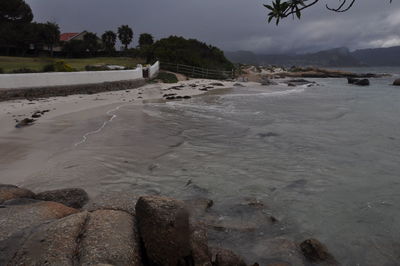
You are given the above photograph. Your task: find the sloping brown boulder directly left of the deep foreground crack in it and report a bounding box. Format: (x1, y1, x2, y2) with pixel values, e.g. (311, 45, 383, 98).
(9, 212, 88, 266)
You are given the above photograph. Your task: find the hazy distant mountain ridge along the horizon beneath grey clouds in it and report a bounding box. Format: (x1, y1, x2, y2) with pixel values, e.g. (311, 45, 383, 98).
(225, 46, 400, 67)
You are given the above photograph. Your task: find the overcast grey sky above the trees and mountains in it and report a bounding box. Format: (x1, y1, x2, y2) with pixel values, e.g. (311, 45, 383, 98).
(26, 0, 400, 53)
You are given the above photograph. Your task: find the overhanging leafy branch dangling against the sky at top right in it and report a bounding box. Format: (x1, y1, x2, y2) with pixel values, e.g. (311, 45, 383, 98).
(264, 0, 392, 25)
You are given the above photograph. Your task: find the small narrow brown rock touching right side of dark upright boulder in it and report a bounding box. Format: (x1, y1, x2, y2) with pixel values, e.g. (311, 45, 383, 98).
(190, 225, 212, 266)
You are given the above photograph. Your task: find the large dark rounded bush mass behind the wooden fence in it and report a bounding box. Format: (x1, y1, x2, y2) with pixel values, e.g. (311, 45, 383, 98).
(151, 36, 234, 70)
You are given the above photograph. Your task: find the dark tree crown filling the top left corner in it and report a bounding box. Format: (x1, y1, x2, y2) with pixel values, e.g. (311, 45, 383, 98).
(0, 0, 33, 24)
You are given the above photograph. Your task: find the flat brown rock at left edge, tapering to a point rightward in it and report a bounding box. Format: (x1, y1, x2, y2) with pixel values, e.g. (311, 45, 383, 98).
(0, 202, 78, 241)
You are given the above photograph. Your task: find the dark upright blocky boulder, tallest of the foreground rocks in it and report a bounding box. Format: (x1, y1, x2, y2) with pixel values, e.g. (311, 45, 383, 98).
(136, 196, 191, 266)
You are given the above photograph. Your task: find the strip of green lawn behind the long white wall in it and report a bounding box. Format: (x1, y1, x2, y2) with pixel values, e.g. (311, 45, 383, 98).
(0, 56, 144, 73)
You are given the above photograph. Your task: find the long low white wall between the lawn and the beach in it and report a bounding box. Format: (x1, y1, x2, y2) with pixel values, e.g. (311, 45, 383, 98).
(0, 68, 143, 89)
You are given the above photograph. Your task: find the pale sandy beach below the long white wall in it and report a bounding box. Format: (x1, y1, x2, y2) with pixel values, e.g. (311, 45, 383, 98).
(0, 79, 233, 191)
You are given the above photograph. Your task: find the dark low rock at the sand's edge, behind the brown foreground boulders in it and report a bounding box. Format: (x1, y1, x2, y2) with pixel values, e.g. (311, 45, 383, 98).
(35, 188, 89, 209)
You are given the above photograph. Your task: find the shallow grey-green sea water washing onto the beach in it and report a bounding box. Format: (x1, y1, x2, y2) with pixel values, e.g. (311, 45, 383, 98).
(18, 68, 400, 265)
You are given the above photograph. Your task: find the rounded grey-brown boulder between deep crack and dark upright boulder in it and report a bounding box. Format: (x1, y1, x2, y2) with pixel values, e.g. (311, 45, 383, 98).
(79, 210, 142, 266)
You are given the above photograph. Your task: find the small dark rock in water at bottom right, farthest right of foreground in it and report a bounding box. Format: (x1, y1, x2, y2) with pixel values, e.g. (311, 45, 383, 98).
(300, 238, 338, 265)
